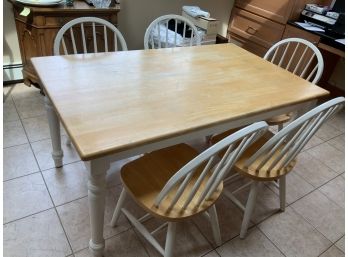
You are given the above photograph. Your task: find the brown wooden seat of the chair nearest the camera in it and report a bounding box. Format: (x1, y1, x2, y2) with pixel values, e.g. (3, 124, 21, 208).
(121, 144, 223, 220)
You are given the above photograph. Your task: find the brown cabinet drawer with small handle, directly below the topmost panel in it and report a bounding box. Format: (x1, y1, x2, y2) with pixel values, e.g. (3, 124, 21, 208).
(228, 8, 285, 49)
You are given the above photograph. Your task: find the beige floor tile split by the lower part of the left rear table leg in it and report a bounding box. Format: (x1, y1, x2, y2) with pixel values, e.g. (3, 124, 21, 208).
(31, 136, 80, 170)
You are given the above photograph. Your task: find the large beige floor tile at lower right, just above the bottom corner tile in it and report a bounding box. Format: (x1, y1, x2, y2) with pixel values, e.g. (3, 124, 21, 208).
(291, 190, 344, 243)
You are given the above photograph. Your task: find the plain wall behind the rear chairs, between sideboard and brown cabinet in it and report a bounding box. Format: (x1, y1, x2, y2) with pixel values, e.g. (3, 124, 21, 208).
(118, 0, 234, 49)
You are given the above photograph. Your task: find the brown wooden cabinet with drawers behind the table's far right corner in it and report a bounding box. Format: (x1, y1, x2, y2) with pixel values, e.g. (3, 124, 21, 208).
(227, 0, 330, 56)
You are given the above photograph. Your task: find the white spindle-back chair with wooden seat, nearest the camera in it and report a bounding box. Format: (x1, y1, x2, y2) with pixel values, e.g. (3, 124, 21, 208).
(111, 122, 268, 257)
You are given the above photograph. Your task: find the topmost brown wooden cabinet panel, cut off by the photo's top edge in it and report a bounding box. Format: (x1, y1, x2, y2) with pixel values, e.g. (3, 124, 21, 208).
(235, 0, 294, 24)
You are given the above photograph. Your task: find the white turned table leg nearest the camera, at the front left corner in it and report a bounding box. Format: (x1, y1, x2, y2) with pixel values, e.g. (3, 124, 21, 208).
(85, 159, 110, 257)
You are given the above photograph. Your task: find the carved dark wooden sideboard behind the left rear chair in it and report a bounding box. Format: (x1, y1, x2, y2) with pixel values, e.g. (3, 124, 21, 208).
(8, 0, 120, 87)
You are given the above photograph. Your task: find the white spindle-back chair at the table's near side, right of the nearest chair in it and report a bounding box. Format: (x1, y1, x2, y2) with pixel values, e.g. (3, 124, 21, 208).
(219, 97, 344, 238)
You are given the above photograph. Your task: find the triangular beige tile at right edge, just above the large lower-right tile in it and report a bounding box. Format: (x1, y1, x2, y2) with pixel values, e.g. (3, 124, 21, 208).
(319, 176, 344, 208)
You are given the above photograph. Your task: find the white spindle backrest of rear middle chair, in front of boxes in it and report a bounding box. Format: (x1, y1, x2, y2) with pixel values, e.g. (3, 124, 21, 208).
(144, 14, 201, 49)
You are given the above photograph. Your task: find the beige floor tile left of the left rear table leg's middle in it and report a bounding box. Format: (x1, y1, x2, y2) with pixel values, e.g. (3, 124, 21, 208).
(23, 115, 66, 144)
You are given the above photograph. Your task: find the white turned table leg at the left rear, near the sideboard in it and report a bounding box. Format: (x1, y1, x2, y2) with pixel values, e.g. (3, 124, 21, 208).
(45, 96, 63, 168)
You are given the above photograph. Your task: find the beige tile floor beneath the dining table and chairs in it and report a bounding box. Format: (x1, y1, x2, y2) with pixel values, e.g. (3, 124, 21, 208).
(3, 84, 345, 257)
